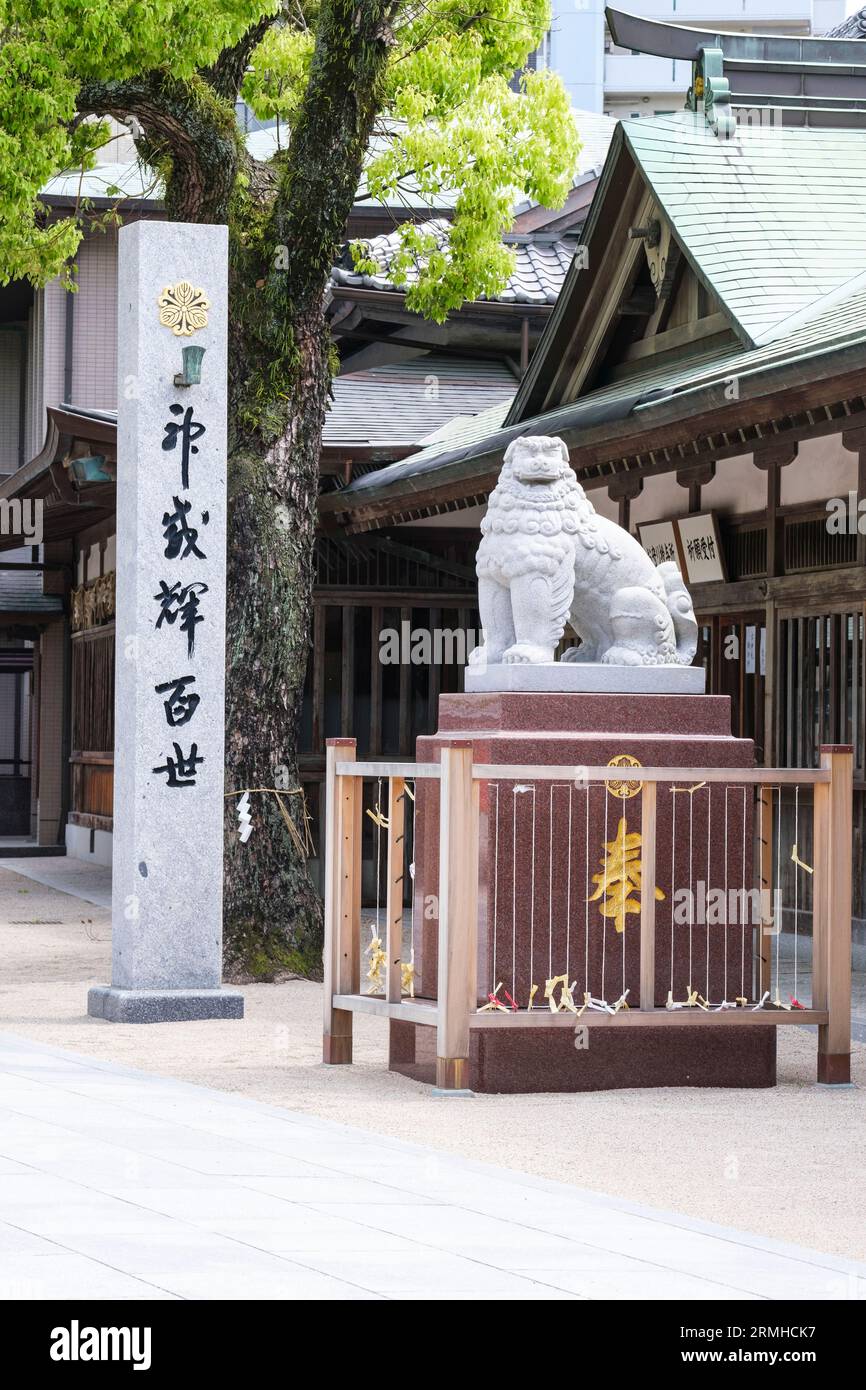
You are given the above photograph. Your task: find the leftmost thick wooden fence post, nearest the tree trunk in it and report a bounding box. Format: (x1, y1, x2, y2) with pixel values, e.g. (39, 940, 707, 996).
(322, 738, 363, 1065)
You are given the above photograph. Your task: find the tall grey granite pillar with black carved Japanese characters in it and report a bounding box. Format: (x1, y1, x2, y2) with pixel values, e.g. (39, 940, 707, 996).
(88, 222, 243, 1023)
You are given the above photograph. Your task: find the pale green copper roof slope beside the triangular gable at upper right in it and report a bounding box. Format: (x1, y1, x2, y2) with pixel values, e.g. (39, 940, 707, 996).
(623, 111, 866, 346)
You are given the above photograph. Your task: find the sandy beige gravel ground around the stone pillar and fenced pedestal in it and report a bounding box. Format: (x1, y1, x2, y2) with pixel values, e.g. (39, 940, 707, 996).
(0, 869, 866, 1259)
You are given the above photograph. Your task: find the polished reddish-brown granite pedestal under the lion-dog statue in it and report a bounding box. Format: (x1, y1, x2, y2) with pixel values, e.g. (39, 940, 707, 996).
(403, 692, 776, 1091)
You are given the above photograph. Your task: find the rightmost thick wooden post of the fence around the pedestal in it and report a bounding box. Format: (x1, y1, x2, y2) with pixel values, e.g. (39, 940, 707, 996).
(812, 744, 853, 1086)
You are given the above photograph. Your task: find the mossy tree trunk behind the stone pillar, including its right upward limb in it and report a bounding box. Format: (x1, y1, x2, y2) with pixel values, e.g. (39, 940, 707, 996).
(218, 0, 396, 979)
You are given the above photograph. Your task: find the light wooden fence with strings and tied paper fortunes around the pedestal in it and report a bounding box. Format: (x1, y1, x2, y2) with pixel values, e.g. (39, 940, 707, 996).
(324, 738, 852, 1090)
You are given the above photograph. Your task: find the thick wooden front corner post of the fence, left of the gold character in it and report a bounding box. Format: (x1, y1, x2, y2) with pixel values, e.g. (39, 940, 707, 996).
(436, 744, 478, 1091)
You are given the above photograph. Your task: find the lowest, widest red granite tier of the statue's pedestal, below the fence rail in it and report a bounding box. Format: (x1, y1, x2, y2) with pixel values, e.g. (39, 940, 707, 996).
(391, 1023, 776, 1094)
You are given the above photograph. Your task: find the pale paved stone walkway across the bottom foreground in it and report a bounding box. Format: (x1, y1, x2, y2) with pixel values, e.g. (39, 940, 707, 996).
(0, 1034, 866, 1300)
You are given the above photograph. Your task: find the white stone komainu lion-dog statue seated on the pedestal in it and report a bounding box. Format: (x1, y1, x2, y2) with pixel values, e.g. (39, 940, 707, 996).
(470, 435, 698, 666)
